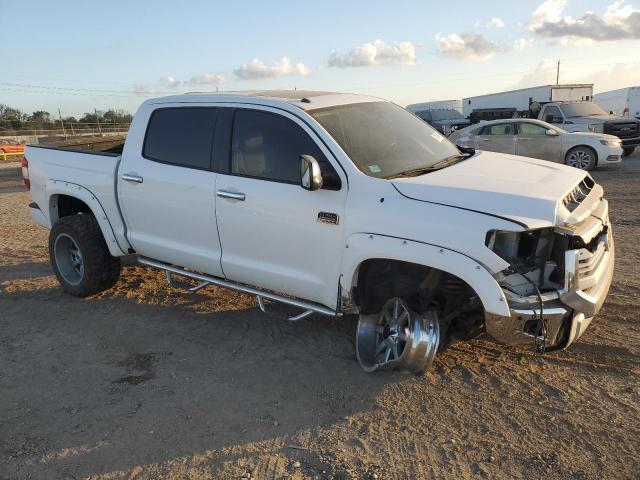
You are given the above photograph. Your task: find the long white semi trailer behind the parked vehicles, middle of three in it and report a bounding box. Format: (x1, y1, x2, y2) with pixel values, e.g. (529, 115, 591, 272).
(462, 83, 593, 118)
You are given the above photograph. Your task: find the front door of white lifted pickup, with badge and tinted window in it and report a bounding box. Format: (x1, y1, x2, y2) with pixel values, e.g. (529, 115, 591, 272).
(216, 106, 347, 308)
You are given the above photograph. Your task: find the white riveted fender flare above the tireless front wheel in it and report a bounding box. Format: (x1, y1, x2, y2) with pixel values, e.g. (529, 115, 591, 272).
(340, 233, 511, 317)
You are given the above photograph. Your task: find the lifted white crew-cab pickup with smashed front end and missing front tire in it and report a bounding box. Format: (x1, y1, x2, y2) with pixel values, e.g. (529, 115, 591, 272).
(23, 91, 614, 372)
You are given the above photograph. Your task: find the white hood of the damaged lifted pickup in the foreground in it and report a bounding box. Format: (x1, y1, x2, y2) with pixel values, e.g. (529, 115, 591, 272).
(392, 151, 586, 228)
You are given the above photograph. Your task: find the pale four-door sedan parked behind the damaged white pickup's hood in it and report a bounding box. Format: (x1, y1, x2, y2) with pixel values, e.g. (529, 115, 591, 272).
(449, 118, 622, 170)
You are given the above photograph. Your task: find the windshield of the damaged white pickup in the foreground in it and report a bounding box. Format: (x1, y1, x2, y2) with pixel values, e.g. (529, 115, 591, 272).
(309, 102, 462, 178)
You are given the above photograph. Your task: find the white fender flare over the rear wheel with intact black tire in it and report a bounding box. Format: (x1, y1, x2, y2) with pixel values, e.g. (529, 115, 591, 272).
(47, 180, 126, 257)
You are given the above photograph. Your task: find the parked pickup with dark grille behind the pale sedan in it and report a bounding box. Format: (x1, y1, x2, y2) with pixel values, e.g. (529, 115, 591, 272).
(538, 102, 640, 156)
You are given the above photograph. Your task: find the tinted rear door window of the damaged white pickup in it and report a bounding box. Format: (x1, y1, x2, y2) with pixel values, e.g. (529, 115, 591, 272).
(142, 107, 217, 169)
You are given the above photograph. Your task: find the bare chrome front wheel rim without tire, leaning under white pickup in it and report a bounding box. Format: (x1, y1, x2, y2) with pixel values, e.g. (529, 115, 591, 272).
(356, 297, 440, 374)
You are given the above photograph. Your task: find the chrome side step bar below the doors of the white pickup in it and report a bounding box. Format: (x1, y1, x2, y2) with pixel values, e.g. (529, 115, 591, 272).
(138, 257, 341, 321)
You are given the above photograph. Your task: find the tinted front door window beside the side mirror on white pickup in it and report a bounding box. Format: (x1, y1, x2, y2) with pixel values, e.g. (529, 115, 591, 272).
(231, 110, 340, 189)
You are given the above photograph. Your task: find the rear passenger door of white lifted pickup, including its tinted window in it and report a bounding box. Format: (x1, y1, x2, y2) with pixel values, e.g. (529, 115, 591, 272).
(117, 105, 222, 276)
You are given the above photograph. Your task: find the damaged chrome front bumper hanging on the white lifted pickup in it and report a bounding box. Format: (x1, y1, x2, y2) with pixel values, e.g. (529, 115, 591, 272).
(485, 221, 615, 350)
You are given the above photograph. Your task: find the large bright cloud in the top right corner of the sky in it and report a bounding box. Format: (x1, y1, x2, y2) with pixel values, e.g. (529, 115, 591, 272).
(527, 0, 640, 44)
